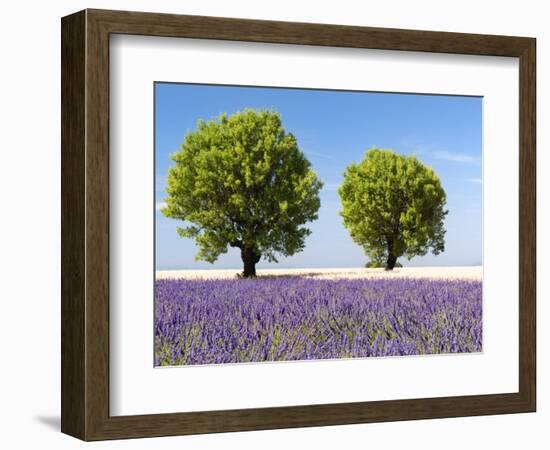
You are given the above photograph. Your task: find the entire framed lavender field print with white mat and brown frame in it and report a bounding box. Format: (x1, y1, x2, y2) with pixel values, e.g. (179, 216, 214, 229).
(62, 10, 536, 440)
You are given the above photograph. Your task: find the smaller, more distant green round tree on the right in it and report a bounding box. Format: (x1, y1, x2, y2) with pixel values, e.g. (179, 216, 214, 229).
(338, 148, 448, 270)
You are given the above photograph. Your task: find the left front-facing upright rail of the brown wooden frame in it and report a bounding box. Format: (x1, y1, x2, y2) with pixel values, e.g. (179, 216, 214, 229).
(85, 13, 109, 439)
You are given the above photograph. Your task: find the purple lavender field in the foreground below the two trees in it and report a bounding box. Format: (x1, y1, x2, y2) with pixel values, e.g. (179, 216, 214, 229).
(155, 277, 482, 365)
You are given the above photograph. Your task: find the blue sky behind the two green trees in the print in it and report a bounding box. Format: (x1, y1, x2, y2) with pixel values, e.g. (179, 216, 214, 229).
(155, 83, 482, 270)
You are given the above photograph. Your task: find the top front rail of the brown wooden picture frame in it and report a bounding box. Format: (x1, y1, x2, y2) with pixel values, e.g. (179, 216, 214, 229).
(88, 10, 529, 57)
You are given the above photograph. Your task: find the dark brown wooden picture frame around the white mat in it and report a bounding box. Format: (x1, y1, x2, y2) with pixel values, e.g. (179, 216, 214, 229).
(61, 10, 536, 440)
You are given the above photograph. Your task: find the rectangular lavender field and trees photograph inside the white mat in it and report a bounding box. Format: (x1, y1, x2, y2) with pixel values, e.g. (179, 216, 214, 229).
(151, 81, 483, 367)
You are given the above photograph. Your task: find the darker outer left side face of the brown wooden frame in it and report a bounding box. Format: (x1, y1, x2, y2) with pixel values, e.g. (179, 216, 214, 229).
(61, 12, 86, 437)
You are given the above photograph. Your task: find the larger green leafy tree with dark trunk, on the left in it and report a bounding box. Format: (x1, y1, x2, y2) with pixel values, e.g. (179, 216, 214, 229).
(162, 109, 323, 277)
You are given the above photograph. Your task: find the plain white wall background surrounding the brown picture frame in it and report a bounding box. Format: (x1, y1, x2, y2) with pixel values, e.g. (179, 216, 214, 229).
(0, 0, 550, 450)
